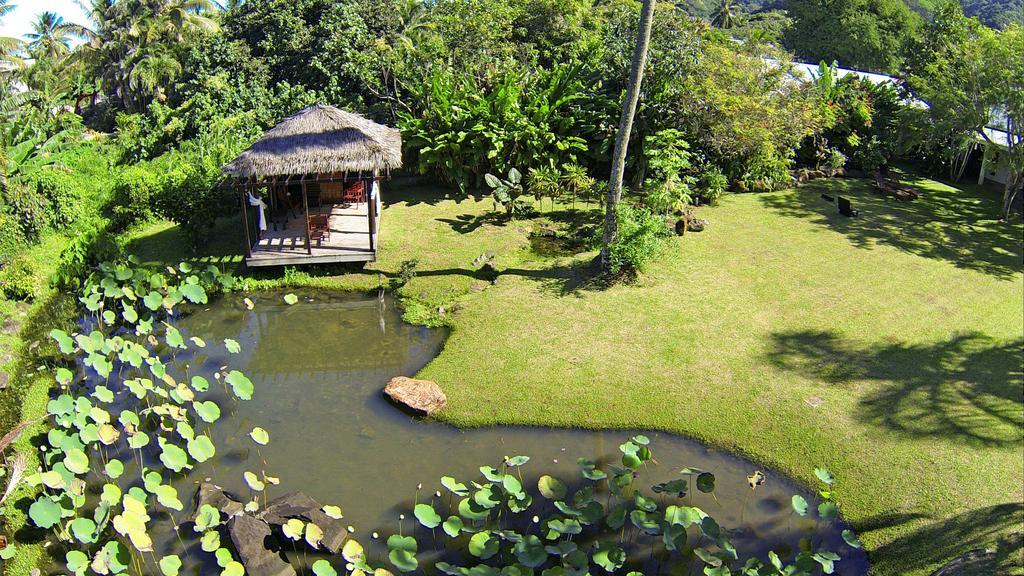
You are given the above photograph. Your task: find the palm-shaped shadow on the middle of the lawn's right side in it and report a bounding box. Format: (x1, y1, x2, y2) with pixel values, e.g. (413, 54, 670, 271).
(768, 331, 1024, 446)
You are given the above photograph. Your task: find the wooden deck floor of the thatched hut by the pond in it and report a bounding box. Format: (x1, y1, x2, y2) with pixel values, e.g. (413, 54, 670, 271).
(246, 202, 377, 266)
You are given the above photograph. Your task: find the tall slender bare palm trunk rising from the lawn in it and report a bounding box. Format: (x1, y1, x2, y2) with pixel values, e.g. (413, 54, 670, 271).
(601, 0, 657, 270)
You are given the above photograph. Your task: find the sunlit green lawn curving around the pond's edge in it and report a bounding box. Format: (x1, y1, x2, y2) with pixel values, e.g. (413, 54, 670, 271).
(130, 172, 1024, 574)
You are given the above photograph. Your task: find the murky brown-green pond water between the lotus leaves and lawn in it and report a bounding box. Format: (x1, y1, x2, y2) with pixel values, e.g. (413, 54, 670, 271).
(72, 292, 867, 575)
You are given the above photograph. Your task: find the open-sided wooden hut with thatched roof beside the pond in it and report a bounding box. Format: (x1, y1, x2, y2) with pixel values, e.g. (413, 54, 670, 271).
(220, 105, 401, 266)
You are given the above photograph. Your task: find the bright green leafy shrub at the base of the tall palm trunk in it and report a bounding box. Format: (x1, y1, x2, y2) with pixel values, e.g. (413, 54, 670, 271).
(608, 203, 669, 274)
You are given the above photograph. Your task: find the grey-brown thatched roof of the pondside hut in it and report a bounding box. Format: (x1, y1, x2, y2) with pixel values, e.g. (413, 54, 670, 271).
(222, 105, 401, 178)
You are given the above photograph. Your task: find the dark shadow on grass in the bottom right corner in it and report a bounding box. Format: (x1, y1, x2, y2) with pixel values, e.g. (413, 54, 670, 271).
(854, 502, 1024, 575)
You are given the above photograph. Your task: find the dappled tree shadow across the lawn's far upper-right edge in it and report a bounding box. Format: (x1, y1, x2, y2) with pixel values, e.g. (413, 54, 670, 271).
(760, 178, 1024, 279)
